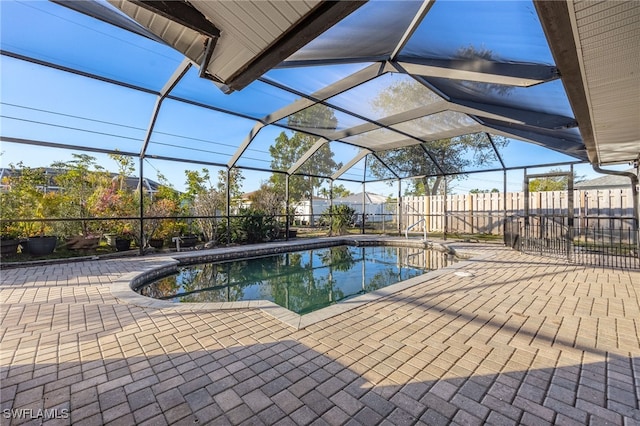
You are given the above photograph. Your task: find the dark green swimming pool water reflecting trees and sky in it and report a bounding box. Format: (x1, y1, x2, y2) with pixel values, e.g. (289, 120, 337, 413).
(136, 246, 454, 315)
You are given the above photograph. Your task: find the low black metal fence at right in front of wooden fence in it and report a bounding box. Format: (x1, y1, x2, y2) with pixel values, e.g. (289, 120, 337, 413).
(504, 216, 640, 269)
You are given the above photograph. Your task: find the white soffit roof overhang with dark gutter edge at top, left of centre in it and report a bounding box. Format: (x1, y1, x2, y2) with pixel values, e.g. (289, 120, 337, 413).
(109, 0, 364, 91)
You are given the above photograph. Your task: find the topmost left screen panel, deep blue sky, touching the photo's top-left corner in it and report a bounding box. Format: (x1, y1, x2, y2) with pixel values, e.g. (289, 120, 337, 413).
(1, 1, 183, 91)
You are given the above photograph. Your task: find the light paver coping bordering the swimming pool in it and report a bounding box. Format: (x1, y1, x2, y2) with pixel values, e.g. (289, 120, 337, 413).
(111, 236, 492, 330)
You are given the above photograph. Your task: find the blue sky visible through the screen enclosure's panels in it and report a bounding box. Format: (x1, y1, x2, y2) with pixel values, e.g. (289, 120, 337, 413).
(0, 0, 628, 195)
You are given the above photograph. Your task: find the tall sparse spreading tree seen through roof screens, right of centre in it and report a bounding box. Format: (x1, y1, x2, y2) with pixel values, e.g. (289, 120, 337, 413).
(369, 46, 511, 195)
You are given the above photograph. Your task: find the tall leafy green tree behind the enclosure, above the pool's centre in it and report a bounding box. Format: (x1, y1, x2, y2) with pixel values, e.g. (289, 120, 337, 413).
(269, 104, 342, 225)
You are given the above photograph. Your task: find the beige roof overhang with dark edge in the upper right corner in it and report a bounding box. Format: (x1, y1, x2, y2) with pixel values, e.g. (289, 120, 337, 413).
(535, 1, 640, 164)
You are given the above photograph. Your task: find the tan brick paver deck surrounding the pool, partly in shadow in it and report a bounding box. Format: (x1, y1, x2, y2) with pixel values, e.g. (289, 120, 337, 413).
(0, 238, 640, 426)
